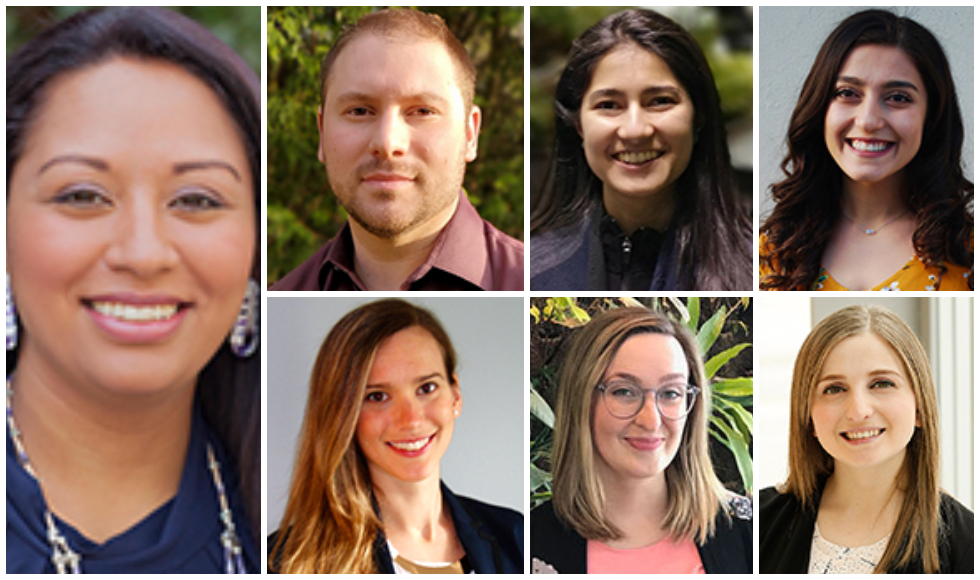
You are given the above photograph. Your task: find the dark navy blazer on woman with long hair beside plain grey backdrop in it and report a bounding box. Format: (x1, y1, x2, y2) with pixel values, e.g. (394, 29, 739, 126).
(269, 484, 524, 574)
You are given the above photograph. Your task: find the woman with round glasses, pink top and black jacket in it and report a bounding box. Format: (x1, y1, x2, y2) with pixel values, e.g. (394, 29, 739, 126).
(531, 307, 752, 574)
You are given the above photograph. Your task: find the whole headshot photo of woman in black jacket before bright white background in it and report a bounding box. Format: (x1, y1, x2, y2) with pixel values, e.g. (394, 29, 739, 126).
(755, 293, 975, 574)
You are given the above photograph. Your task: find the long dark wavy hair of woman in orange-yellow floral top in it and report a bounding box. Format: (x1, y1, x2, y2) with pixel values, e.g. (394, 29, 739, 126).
(760, 10, 973, 290)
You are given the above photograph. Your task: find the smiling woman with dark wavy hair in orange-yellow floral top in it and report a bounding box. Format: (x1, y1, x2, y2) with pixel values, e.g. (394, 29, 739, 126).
(760, 10, 973, 290)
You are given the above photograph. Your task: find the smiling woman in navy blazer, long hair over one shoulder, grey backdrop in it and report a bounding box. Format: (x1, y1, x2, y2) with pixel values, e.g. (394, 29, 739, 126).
(268, 299, 524, 574)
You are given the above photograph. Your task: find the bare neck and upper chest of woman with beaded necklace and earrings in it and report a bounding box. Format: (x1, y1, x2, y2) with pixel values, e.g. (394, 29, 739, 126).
(11, 353, 194, 542)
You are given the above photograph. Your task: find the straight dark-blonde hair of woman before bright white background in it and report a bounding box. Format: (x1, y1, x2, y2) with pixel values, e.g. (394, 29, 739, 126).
(783, 305, 940, 573)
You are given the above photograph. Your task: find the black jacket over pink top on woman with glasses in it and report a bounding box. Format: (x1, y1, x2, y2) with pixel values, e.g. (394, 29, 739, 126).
(531, 497, 752, 574)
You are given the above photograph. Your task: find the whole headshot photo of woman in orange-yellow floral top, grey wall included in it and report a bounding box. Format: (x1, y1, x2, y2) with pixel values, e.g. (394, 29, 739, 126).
(759, 6, 974, 291)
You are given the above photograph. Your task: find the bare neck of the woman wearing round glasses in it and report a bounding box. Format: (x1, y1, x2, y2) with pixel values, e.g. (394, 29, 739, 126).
(598, 466, 670, 549)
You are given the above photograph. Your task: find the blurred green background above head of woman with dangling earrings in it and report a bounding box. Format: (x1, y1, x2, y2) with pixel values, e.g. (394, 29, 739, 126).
(6, 6, 262, 74)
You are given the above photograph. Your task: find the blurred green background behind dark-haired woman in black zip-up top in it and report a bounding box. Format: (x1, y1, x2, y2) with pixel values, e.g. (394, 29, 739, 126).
(528, 6, 753, 208)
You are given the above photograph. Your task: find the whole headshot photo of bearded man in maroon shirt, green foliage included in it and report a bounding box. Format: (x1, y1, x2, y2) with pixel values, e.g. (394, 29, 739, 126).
(268, 6, 524, 291)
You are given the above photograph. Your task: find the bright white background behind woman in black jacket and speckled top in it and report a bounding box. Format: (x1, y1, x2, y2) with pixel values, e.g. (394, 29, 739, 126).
(754, 292, 974, 508)
